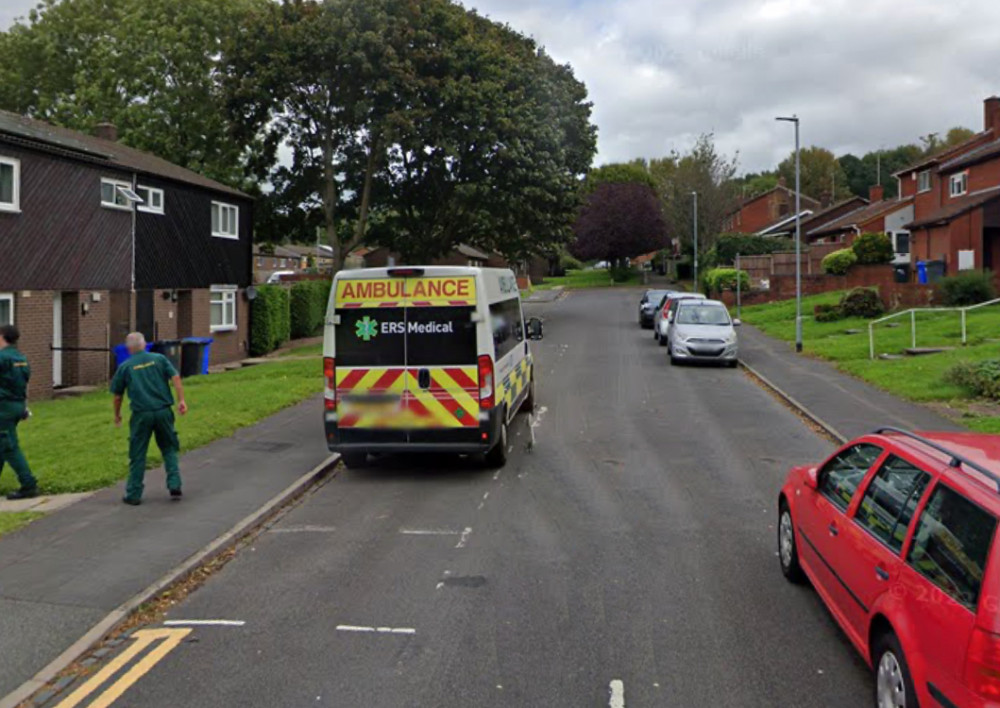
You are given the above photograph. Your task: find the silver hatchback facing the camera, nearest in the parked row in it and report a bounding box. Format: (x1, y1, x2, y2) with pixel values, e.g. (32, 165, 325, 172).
(667, 300, 740, 366)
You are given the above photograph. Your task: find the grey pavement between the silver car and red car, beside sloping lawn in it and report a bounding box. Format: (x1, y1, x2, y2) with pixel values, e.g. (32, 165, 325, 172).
(739, 325, 965, 439)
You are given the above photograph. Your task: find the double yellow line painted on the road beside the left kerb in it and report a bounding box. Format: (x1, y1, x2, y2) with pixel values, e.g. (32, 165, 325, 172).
(56, 628, 191, 708)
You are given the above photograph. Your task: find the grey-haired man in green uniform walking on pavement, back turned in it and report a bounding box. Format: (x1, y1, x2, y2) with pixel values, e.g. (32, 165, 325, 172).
(111, 332, 187, 506)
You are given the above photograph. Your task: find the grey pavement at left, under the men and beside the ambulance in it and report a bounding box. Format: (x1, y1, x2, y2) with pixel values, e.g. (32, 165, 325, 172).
(0, 396, 329, 696)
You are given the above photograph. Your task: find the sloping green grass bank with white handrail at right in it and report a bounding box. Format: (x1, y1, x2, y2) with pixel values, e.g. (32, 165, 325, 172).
(742, 293, 1000, 432)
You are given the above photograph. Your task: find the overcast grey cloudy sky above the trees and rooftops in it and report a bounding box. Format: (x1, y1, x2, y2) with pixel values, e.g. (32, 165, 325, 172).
(7, 0, 1000, 171)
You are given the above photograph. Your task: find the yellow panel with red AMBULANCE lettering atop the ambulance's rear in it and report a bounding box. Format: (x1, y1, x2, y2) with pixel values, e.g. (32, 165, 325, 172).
(336, 276, 476, 310)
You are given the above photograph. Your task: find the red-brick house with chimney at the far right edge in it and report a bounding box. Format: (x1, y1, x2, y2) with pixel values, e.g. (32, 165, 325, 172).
(895, 96, 1000, 274)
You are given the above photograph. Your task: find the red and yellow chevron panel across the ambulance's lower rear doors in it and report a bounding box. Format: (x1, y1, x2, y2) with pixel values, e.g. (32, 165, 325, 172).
(337, 366, 479, 429)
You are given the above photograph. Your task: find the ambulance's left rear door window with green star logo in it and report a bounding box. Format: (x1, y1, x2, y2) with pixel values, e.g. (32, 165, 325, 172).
(336, 307, 406, 367)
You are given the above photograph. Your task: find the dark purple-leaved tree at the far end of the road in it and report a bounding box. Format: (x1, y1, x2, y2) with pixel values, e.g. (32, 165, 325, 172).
(570, 183, 667, 263)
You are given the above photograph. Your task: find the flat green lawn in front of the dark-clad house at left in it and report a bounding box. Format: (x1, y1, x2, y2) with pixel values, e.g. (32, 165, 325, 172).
(0, 359, 322, 494)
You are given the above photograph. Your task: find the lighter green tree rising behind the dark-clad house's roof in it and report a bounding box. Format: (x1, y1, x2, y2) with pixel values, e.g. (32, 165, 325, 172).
(0, 0, 267, 185)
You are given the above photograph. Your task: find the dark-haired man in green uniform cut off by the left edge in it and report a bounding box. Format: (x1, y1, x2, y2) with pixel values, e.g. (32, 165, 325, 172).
(0, 325, 38, 499)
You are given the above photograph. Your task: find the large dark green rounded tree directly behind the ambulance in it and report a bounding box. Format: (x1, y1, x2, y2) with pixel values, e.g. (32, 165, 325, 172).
(226, 0, 595, 266)
